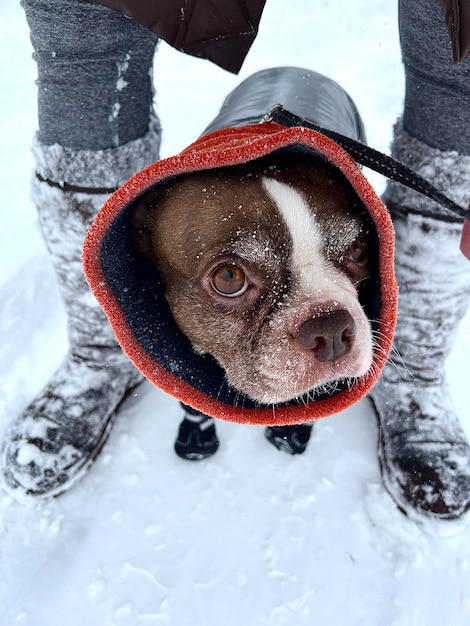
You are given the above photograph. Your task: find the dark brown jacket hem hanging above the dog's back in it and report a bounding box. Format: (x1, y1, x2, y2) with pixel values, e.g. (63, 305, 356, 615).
(87, 0, 266, 74)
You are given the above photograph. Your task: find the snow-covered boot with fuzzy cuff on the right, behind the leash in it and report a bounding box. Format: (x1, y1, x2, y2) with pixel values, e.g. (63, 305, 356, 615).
(370, 126, 470, 519)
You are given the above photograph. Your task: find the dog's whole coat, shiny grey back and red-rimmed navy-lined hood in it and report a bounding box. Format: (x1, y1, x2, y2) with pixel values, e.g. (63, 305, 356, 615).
(83, 68, 397, 425)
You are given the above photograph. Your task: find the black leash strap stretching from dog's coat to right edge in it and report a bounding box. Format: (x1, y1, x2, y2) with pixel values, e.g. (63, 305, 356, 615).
(264, 104, 470, 220)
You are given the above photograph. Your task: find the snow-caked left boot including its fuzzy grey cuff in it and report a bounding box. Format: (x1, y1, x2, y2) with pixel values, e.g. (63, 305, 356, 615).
(1, 130, 159, 500)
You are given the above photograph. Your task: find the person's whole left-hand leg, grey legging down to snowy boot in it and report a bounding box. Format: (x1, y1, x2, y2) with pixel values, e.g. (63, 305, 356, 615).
(2, 0, 160, 497)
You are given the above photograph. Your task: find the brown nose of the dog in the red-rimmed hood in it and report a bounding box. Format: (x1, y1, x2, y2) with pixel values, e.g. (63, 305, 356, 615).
(296, 309, 356, 361)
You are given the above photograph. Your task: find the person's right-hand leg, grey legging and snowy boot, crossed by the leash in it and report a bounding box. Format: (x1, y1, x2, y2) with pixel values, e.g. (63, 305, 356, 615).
(371, 0, 470, 519)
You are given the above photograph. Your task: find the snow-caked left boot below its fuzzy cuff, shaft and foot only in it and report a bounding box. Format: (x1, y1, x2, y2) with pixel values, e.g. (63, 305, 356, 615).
(2, 182, 141, 496)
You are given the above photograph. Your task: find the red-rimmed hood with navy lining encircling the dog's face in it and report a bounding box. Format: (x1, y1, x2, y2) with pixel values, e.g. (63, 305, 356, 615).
(84, 123, 396, 424)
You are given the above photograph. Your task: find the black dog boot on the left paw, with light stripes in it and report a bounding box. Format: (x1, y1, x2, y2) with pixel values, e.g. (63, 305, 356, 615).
(175, 403, 219, 461)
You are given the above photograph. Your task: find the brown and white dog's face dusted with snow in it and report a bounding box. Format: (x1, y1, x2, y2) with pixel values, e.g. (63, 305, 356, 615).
(134, 156, 372, 404)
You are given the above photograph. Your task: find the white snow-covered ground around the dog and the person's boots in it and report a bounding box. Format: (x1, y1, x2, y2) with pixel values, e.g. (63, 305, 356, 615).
(0, 0, 470, 626)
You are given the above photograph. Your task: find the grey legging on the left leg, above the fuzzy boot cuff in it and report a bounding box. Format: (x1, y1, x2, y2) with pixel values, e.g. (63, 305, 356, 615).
(22, 0, 158, 150)
